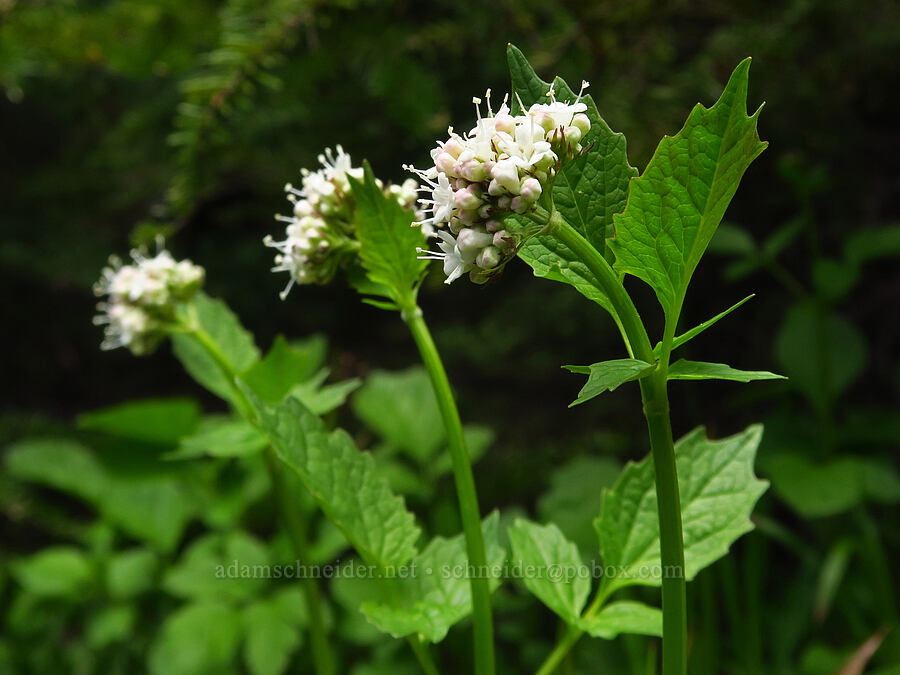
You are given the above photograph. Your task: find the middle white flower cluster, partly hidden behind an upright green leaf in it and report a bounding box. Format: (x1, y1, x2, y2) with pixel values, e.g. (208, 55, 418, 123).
(263, 145, 418, 299)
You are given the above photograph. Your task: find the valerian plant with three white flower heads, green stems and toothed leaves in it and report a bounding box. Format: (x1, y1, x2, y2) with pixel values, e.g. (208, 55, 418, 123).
(86, 45, 780, 675)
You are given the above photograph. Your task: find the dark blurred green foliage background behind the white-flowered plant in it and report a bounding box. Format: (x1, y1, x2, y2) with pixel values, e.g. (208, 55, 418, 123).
(0, 0, 900, 675)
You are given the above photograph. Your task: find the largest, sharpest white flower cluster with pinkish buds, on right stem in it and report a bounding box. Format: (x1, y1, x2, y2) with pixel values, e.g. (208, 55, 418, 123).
(406, 82, 591, 284)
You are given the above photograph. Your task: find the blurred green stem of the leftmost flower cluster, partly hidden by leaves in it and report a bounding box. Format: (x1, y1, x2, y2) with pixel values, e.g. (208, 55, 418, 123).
(188, 321, 337, 675)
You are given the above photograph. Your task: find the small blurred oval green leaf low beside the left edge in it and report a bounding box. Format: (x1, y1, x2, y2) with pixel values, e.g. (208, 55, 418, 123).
(10, 546, 94, 598)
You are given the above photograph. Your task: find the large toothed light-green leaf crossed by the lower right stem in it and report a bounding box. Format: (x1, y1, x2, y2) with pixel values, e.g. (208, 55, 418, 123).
(594, 425, 768, 589)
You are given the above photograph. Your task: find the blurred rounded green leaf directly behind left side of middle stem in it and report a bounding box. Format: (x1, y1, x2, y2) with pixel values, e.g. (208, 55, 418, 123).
(353, 366, 446, 461)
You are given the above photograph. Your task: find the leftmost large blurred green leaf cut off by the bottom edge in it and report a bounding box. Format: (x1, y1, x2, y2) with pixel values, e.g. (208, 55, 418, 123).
(148, 602, 242, 675)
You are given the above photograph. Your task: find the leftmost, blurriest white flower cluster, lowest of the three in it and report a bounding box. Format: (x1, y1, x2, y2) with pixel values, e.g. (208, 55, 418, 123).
(94, 250, 205, 356)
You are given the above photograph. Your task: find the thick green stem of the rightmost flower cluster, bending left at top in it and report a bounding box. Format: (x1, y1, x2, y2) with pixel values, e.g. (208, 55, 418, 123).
(546, 211, 687, 675)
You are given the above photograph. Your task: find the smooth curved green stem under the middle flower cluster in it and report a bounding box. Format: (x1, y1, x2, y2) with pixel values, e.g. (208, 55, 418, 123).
(403, 306, 495, 675)
